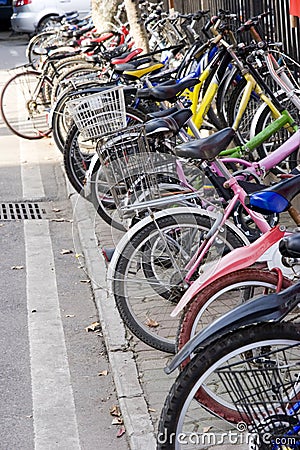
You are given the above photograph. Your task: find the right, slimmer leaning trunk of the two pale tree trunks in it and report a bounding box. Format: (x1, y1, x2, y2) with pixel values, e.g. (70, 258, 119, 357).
(124, 0, 149, 53)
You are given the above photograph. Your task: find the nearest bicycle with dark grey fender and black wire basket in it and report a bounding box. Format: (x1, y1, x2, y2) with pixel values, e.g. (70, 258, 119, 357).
(158, 233, 300, 450)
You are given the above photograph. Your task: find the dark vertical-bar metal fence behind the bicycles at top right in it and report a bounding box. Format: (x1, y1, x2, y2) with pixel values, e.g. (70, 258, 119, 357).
(165, 0, 300, 61)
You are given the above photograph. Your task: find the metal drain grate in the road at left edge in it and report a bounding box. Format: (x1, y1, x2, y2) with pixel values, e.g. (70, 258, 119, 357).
(0, 203, 46, 220)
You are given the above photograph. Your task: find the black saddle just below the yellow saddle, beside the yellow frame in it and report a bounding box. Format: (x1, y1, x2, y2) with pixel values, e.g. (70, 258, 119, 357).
(138, 78, 200, 102)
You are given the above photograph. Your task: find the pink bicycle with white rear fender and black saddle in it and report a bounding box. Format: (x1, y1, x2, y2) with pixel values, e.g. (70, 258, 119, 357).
(108, 125, 300, 353)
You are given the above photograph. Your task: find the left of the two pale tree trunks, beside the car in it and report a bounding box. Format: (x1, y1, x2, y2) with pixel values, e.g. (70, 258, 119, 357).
(92, 0, 120, 33)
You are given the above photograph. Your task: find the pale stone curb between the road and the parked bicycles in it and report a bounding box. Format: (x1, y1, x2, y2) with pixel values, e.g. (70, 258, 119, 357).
(63, 181, 156, 450)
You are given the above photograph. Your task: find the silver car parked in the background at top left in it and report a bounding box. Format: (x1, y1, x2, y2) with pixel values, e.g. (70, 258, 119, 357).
(11, 0, 91, 33)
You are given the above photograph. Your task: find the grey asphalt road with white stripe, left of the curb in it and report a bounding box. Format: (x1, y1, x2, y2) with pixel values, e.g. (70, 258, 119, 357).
(0, 32, 128, 450)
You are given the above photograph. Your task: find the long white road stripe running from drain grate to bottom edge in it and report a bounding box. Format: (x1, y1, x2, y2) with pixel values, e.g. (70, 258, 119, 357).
(24, 220, 80, 450)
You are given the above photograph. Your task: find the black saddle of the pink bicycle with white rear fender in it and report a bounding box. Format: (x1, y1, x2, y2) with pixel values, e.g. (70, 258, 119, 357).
(175, 127, 235, 161)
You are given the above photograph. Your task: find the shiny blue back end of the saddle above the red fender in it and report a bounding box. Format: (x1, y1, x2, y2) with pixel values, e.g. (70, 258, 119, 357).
(246, 191, 290, 214)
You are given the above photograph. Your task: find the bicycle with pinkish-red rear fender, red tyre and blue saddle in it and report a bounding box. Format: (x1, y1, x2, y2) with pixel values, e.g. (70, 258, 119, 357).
(172, 175, 300, 372)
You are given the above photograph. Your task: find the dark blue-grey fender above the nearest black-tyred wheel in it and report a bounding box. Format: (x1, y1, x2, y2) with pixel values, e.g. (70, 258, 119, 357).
(164, 284, 300, 374)
